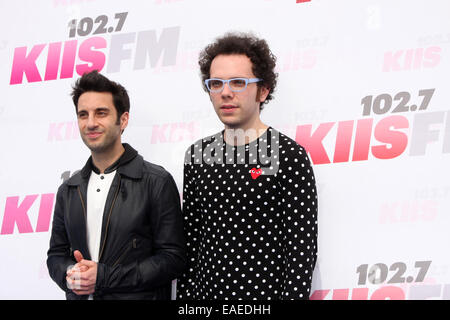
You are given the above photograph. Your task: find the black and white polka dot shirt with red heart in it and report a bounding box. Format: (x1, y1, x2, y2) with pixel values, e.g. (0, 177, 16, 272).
(177, 128, 317, 300)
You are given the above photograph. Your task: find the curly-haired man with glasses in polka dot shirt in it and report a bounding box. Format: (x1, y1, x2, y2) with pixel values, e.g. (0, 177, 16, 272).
(177, 33, 317, 300)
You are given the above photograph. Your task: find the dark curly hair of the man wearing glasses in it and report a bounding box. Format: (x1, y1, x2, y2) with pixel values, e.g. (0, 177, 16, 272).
(198, 32, 278, 110)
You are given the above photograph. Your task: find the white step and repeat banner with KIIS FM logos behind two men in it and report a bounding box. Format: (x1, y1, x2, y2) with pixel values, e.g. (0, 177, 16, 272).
(0, 0, 450, 300)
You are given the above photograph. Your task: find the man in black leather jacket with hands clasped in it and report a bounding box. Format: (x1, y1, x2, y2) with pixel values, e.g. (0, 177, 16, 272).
(47, 71, 186, 300)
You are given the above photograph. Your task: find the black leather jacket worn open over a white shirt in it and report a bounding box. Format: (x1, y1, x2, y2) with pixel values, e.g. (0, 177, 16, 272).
(47, 144, 186, 300)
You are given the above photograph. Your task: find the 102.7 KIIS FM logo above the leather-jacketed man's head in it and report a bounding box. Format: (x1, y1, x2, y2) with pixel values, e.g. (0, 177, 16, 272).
(10, 13, 180, 85)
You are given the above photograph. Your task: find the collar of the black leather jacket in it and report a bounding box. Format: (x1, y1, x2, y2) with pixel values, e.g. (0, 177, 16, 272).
(67, 143, 143, 185)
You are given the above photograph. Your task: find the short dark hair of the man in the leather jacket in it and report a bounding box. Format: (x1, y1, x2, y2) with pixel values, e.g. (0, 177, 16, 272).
(71, 70, 130, 121)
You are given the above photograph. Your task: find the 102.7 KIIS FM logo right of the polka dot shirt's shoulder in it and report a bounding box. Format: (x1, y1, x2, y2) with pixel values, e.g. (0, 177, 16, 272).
(296, 89, 450, 164)
